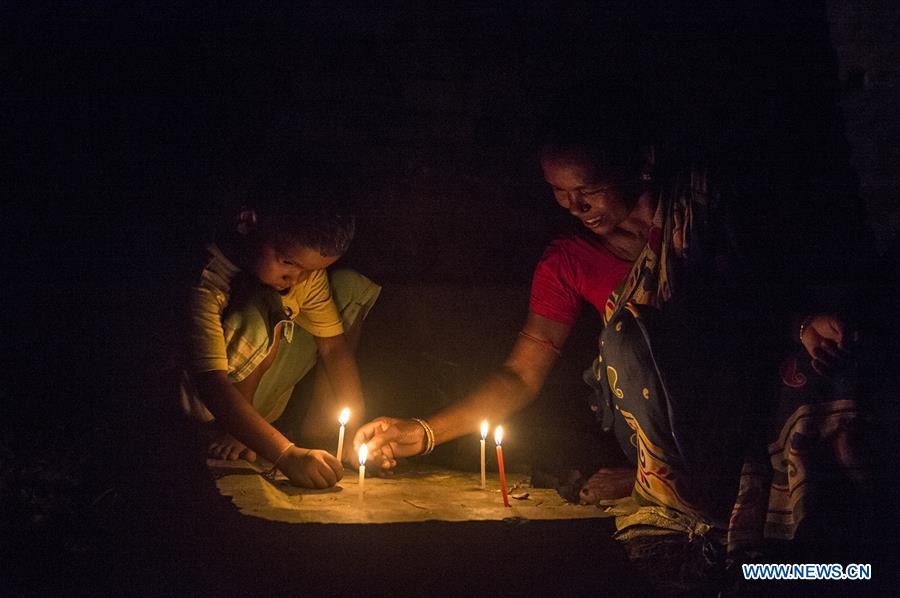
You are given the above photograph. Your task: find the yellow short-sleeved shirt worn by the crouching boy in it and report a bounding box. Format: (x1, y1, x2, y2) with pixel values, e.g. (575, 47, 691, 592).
(188, 245, 344, 382)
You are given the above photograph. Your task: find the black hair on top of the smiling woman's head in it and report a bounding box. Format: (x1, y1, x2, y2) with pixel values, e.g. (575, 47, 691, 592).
(536, 87, 650, 177)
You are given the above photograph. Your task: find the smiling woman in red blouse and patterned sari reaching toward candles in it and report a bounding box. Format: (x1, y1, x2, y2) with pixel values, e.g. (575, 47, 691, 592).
(354, 104, 863, 548)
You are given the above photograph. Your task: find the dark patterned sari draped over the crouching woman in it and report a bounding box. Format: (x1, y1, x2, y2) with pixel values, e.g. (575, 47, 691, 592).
(592, 165, 868, 550)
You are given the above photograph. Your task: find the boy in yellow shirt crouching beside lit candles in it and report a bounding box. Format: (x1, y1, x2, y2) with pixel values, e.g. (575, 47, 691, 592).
(182, 192, 381, 488)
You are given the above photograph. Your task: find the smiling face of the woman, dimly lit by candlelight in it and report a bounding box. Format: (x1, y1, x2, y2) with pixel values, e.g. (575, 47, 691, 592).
(541, 151, 640, 236)
